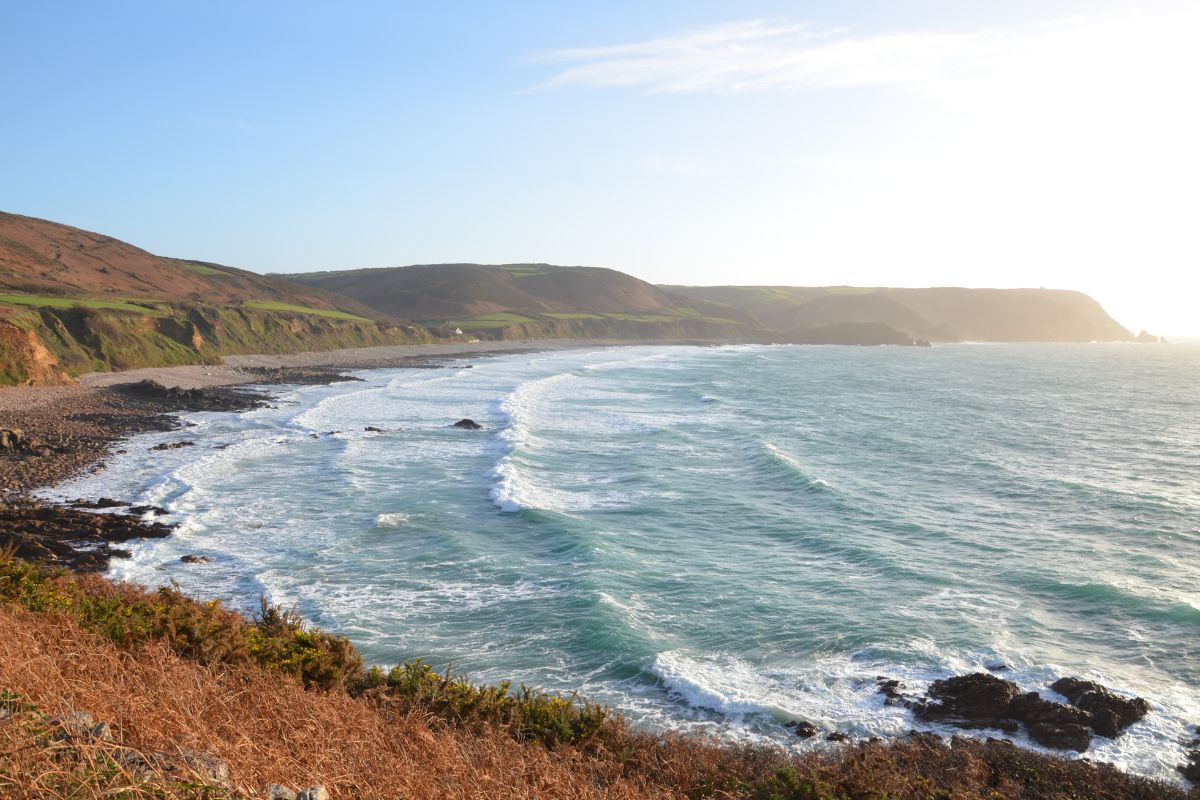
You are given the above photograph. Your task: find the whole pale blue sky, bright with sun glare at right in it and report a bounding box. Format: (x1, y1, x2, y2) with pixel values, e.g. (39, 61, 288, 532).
(0, 0, 1200, 336)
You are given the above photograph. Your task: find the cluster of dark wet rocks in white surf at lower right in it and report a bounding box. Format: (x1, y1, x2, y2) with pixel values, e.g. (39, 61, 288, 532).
(876, 673, 1150, 753)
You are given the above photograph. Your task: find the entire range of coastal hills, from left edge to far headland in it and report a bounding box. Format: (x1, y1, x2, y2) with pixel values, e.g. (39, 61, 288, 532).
(0, 212, 1154, 384)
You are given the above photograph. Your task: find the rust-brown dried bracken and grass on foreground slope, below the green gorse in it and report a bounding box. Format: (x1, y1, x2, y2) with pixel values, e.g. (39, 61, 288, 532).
(0, 599, 1200, 800)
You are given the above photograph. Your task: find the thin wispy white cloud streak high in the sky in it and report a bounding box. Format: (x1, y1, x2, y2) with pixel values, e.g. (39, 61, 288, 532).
(536, 19, 1086, 92)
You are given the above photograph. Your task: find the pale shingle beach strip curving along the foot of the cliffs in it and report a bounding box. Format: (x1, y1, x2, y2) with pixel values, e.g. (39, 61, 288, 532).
(79, 339, 638, 389)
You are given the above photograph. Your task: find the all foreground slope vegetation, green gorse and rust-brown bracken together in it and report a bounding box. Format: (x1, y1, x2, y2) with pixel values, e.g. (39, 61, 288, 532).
(0, 553, 1200, 800)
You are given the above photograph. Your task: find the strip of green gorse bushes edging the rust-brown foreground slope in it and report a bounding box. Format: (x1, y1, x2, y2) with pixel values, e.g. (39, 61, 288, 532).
(0, 552, 612, 746)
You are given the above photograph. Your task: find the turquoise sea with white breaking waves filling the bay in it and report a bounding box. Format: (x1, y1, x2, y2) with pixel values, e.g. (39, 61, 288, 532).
(46, 345, 1200, 777)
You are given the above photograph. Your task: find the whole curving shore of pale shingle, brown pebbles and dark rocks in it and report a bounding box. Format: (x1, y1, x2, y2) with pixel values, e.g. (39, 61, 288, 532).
(0, 339, 631, 572)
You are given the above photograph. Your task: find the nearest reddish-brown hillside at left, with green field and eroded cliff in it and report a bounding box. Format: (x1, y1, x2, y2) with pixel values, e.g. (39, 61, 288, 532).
(0, 213, 430, 384)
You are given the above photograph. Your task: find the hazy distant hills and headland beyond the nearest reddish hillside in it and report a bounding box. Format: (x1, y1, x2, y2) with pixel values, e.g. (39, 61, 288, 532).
(284, 264, 1134, 344)
